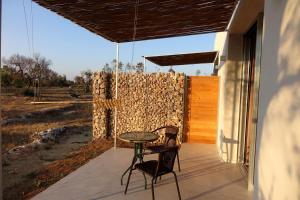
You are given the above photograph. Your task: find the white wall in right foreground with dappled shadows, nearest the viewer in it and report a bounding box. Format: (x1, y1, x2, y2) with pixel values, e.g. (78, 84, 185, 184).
(254, 0, 300, 200)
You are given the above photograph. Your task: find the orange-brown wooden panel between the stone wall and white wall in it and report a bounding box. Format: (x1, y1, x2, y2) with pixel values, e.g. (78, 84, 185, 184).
(185, 76, 219, 144)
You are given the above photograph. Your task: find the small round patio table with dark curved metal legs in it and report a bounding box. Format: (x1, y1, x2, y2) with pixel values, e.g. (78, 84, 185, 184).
(119, 131, 159, 185)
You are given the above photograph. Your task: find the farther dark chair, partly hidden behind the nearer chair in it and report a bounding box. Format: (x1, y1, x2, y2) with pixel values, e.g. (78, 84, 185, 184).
(145, 125, 181, 172)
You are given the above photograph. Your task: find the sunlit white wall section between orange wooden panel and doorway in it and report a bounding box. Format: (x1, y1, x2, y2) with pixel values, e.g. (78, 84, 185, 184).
(215, 33, 243, 163)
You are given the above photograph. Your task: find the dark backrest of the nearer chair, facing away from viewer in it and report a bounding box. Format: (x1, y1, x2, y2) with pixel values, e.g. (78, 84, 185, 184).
(158, 146, 178, 173)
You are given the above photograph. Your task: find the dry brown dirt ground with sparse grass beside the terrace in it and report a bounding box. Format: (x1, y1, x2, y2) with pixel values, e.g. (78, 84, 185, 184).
(1, 89, 120, 199)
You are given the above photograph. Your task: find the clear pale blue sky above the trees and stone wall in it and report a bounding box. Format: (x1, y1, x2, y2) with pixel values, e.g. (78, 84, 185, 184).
(1, 0, 215, 79)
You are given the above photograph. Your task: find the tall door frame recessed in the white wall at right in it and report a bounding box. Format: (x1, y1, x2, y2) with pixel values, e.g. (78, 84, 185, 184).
(239, 13, 263, 191)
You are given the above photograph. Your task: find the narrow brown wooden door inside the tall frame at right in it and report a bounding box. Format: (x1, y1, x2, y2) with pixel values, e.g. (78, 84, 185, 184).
(244, 26, 256, 170)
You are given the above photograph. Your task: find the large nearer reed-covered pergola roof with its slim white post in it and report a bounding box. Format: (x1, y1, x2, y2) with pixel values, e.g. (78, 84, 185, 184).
(33, 0, 237, 147)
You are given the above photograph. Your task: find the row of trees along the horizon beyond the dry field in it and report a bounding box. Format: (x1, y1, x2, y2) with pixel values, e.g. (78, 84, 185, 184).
(0, 54, 144, 96)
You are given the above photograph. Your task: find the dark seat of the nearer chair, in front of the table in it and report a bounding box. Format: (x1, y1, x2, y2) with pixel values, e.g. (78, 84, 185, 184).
(135, 160, 172, 177)
